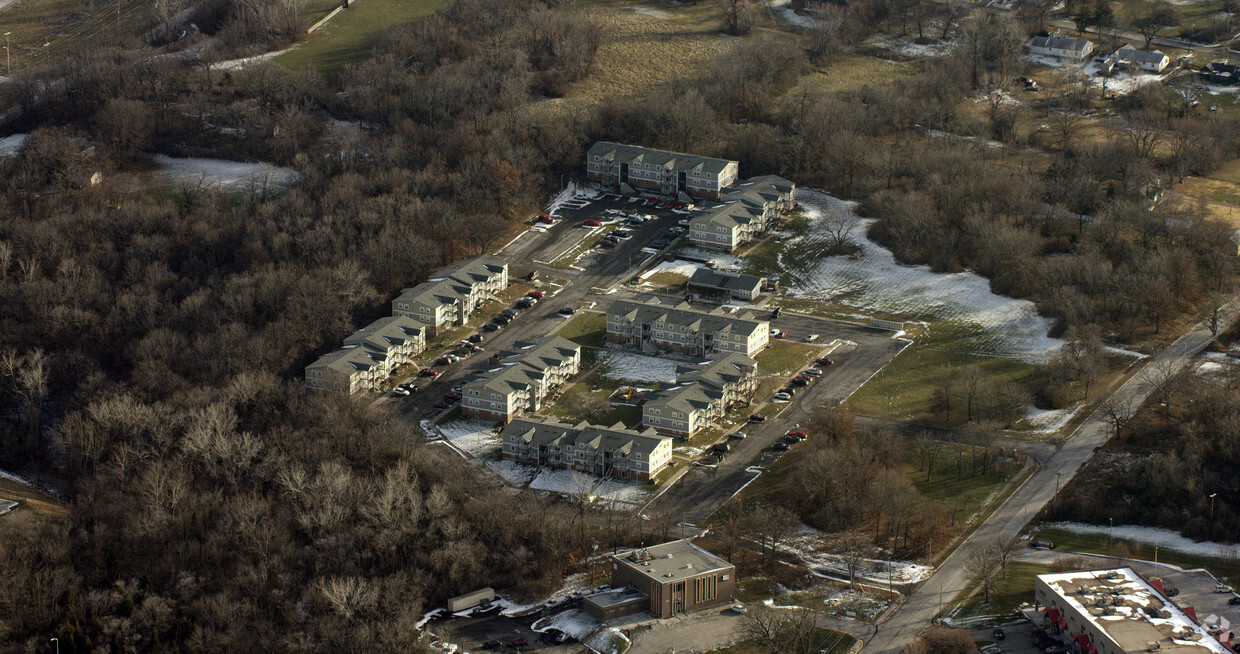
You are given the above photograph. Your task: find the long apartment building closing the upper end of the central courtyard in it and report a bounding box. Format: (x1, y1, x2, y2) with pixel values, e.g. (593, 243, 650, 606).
(608, 300, 770, 357)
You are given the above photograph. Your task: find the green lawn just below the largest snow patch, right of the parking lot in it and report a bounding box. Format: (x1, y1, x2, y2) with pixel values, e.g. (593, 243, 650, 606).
(848, 323, 1034, 426)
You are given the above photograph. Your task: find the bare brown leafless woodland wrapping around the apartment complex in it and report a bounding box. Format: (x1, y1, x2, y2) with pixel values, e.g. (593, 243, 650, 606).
(0, 0, 1240, 652)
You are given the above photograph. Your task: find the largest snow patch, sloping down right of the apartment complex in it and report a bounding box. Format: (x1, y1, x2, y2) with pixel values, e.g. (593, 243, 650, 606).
(780, 189, 1063, 360)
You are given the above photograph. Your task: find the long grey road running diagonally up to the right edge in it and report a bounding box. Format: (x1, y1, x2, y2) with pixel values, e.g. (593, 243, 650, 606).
(866, 300, 1240, 653)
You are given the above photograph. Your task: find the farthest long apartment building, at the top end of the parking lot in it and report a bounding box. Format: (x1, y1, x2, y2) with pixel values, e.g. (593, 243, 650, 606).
(585, 141, 740, 200)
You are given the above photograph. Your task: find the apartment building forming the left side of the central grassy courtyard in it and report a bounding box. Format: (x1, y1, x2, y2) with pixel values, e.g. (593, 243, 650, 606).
(461, 336, 582, 423)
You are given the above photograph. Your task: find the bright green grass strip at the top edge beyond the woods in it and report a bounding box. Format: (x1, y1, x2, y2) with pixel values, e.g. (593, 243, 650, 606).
(275, 0, 445, 73)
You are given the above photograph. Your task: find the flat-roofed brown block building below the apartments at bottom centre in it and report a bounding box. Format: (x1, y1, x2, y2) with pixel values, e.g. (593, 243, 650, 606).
(582, 539, 737, 620)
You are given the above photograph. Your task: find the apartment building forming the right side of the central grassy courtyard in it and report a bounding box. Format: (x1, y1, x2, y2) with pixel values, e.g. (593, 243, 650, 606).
(641, 354, 758, 438)
